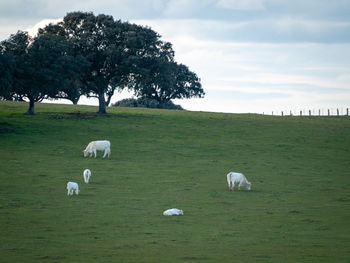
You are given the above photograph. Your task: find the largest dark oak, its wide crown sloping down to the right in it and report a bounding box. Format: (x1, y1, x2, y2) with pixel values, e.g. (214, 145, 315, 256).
(39, 12, 204, 113)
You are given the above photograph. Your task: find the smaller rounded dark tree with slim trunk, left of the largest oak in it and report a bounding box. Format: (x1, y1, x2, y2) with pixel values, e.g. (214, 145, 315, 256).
(0, 31, 86, 115)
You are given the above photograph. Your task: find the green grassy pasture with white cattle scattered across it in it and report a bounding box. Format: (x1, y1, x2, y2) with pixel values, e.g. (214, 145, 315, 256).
(0, 102, 350, 263)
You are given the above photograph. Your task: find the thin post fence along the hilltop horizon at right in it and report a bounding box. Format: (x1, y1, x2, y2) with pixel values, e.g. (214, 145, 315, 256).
(263, 108, 349, 116)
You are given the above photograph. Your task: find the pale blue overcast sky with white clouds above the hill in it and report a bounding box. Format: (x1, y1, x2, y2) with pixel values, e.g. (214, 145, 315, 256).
(0, 0, 350, 114)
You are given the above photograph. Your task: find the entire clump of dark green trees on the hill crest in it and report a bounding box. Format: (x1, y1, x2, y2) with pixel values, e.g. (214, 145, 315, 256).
(0, 12, 205, 114)
